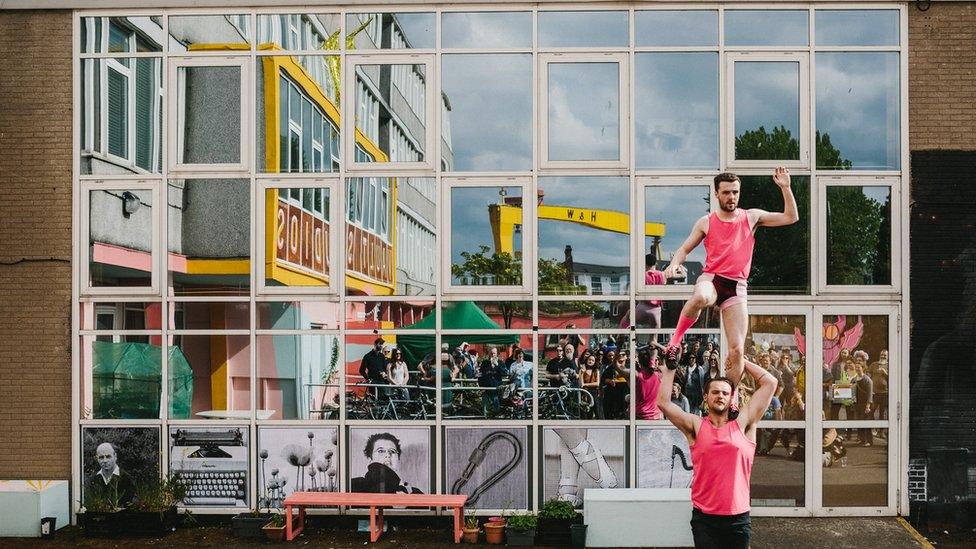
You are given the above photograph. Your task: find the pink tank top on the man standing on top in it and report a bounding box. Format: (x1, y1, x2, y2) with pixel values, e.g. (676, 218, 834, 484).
(704, 208, 756, 282)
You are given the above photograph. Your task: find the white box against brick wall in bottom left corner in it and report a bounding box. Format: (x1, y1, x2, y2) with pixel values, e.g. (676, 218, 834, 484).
(0, 480, 70, 538)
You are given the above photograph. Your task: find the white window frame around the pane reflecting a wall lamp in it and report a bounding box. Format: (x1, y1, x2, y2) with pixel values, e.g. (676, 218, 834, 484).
(78, 179, 161, 296)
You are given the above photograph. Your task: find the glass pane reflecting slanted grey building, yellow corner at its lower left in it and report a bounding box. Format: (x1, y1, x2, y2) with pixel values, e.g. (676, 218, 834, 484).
(356, 65, 427, 162)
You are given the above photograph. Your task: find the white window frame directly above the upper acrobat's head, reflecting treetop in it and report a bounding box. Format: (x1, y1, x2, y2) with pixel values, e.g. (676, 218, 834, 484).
(722, 51, 812, 169)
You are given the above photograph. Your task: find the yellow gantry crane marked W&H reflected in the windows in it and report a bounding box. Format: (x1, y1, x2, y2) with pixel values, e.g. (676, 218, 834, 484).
(488, 192, 665, 257)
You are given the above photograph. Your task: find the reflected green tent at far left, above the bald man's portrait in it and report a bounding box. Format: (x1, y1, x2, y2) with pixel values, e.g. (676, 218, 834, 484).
(92, 341, 193, 419)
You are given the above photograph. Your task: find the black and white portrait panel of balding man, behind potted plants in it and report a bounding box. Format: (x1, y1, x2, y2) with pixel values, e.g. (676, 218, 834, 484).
(81, 427, 160, 511)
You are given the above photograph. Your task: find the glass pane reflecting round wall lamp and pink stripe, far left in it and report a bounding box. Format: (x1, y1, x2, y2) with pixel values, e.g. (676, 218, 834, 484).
(88, 189, 153, 287)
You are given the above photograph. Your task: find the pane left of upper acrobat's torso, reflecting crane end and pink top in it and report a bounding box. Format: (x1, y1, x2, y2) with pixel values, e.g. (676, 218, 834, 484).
(643, 185, 712, 286)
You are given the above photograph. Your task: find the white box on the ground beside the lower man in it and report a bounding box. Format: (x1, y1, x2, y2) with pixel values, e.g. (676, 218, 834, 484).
(583, 488, 695, 547)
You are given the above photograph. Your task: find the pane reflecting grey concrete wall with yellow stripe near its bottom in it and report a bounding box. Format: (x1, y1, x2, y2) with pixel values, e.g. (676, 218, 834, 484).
(167, 179, 251, 295)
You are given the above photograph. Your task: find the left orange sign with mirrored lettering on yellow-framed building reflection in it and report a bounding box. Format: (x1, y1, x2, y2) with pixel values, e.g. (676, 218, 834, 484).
(275, 198, 329, 277)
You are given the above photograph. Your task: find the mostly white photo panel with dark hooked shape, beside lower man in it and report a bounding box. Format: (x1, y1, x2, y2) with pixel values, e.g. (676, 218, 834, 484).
(637, 427, 693, 488)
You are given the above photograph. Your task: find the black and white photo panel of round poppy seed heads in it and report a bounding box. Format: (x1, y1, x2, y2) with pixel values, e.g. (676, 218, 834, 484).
(257, 427, 339, 509)
